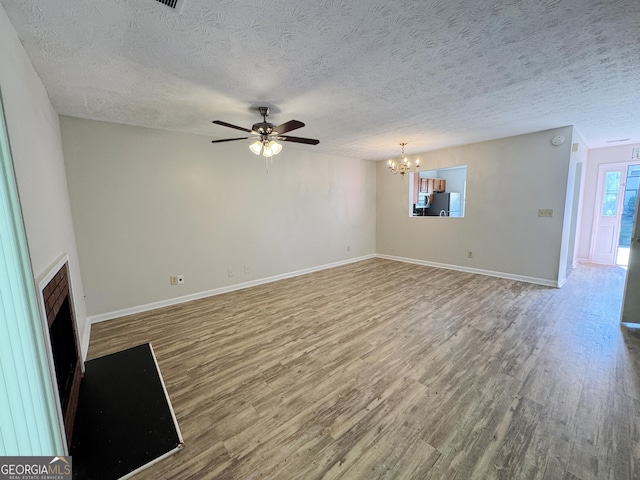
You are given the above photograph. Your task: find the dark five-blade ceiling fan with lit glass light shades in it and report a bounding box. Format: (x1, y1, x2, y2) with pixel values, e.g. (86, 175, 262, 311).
(211, 107, 320, 157)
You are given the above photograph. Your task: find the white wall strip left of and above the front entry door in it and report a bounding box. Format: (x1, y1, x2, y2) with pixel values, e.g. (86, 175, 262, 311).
(577, 145, 637, 262)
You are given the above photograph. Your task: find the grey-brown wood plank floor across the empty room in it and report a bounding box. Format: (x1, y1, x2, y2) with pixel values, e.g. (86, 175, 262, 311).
(89, 259, 640, 480)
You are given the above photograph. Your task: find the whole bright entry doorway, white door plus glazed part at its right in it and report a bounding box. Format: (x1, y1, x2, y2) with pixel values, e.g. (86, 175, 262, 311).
(590, 162, 640, 267)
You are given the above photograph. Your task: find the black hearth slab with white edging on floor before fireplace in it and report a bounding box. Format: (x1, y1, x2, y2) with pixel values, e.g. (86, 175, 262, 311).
(69, 343, 182, 480)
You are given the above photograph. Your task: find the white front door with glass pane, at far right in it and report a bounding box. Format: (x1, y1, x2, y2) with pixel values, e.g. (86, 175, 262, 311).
(591, 163, 635, 265)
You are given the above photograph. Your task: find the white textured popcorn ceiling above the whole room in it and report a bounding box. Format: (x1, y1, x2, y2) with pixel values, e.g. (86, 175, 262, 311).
(0, 0, 640, 159)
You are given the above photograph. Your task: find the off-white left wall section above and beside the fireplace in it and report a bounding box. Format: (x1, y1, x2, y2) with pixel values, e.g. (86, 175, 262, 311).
(0, 6, 89, 355)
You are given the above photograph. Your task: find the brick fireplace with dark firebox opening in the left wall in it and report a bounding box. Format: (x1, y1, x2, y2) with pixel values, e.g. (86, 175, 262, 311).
(42, 262, 82, 445)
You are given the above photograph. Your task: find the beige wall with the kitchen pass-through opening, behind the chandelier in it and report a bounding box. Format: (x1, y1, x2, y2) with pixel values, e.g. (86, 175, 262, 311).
(376, 127, 573, 285)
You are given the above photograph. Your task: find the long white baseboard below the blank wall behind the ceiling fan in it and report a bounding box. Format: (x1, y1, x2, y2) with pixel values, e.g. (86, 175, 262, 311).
(88, 254, 376, 324)
